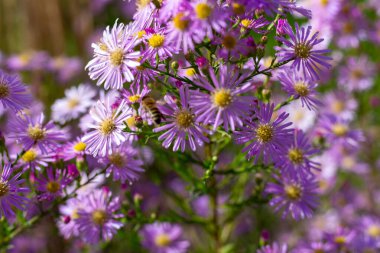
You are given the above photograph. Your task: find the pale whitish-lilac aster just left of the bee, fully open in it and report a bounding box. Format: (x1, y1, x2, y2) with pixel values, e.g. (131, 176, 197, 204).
(82, 97, 133, 156)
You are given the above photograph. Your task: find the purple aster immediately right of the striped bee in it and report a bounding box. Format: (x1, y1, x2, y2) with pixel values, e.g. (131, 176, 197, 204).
(153, 86, 208, 152)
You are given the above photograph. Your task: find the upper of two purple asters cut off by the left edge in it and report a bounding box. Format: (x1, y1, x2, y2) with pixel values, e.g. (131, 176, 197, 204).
(0, 70, 32, 112)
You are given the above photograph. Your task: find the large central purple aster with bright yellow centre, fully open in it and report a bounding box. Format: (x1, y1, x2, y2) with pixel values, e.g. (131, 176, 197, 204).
(190, 65, 253, 131)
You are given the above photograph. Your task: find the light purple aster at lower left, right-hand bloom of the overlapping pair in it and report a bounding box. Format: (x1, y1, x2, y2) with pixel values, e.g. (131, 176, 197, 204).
(76, 190, 123, 244)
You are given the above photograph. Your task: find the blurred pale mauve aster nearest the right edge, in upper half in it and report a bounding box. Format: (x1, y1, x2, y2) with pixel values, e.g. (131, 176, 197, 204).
(338, 56, 376, 92)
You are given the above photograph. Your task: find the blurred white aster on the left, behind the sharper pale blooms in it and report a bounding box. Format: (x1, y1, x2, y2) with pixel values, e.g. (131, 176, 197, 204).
(52, 84, 96, 124)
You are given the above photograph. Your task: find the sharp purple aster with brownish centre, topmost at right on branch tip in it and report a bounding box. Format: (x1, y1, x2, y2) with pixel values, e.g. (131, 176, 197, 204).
(276, 24, 331, 80)
